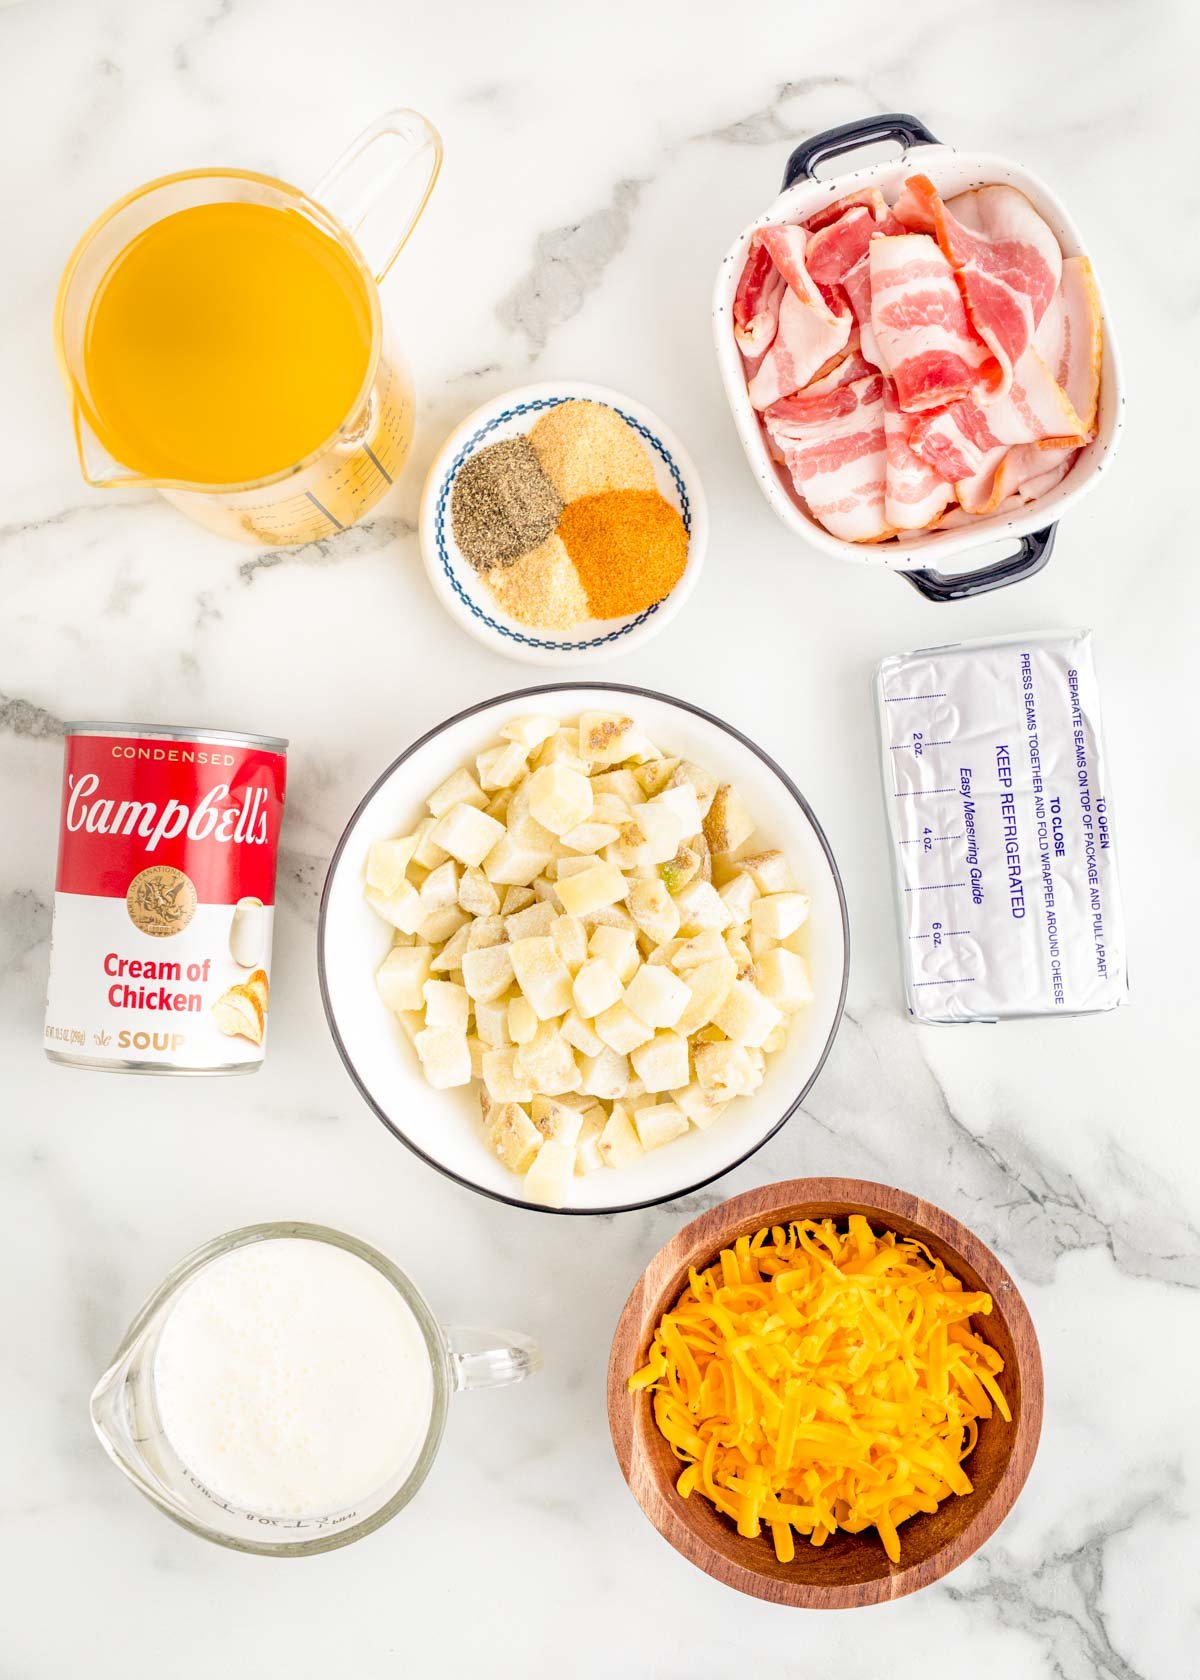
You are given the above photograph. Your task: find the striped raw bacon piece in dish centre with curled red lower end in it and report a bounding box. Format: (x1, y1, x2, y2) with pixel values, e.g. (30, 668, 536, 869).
(869, 234, 998, 413)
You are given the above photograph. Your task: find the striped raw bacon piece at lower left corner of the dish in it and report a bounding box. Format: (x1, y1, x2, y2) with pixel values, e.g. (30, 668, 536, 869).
(766, 373, 891, 543)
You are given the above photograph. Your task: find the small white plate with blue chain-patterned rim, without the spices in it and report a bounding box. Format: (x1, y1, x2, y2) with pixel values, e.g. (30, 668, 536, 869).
(418, 383, 708, 669)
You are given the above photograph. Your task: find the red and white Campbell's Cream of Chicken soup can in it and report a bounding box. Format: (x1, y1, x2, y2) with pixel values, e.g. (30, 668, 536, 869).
(45, 722, 287, 1074)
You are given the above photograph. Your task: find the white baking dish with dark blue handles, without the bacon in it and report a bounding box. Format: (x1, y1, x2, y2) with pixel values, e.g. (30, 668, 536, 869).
(713, 113, 1124, 601)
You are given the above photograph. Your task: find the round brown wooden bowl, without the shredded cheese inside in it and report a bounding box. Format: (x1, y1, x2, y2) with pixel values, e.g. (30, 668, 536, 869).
(608, 1178, 1042, 1609)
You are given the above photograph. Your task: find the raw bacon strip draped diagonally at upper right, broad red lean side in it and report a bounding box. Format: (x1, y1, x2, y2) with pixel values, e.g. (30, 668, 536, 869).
(896, 175, 1062, 396)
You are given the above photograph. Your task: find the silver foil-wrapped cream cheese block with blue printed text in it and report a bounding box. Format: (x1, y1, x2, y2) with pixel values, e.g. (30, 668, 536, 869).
(876, 630, 1128, 1023)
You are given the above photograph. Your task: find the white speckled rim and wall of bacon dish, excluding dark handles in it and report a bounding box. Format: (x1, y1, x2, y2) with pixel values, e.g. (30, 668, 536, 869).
(713, 146, 1124, 571)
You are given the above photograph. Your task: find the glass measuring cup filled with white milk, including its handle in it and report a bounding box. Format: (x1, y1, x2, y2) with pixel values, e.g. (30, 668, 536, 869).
(91, 1223, 541, 1557)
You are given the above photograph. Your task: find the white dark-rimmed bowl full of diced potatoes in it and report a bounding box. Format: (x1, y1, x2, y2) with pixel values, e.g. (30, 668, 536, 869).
(318, 684, 849, 1213)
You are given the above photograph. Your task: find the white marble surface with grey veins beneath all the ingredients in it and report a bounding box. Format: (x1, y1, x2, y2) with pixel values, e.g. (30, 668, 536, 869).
(0, 0, 1200, 1680)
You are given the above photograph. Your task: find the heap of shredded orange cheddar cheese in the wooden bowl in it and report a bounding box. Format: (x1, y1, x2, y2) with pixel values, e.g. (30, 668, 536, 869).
(629, 1215, 1012, 1562)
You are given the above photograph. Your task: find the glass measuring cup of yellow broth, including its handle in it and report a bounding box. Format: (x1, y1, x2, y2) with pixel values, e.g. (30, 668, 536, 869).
(55, 111, 442, 546)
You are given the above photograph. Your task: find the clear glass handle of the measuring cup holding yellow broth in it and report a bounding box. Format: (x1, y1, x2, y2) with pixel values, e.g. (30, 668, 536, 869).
(313, 111, 442, 281)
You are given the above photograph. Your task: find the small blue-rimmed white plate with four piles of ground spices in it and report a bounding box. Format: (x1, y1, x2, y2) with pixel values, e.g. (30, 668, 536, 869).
(420, 381, 708, 665)
